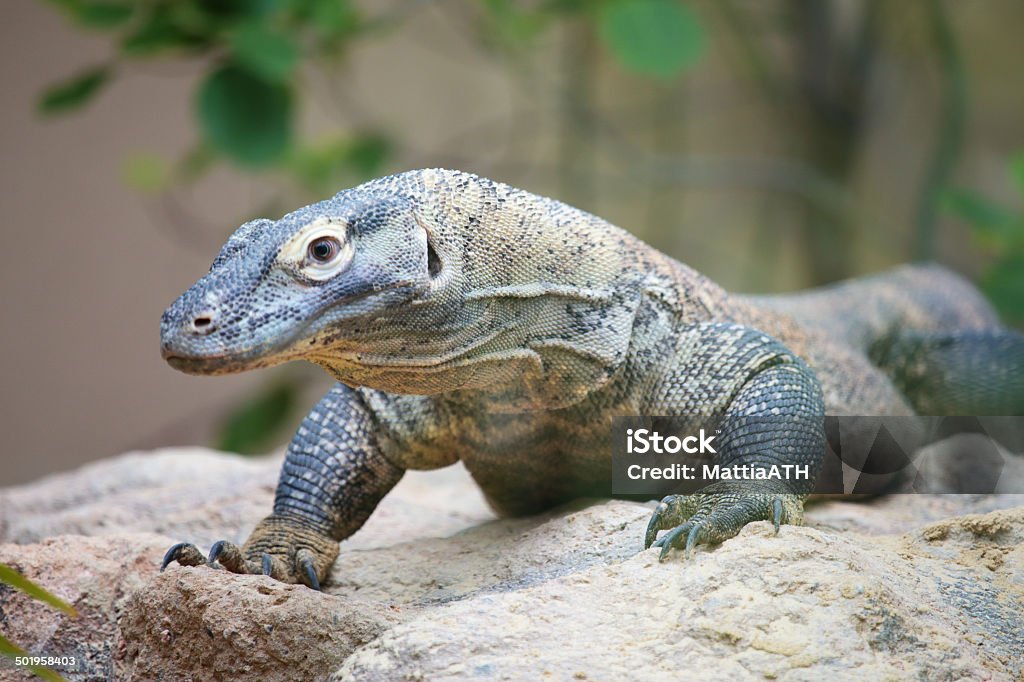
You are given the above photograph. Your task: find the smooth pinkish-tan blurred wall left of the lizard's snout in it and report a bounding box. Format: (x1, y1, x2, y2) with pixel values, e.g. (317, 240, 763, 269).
(0, 0, 266, 484)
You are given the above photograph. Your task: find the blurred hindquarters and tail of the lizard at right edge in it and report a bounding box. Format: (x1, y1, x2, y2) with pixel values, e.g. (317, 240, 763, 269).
(751, 265, 1024, 416)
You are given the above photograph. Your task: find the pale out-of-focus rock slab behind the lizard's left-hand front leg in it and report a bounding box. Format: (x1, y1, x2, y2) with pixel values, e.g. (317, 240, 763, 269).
(0, 447, 494, 547)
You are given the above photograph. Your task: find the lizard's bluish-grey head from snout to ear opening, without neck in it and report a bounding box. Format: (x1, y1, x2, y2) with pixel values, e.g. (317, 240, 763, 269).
(160, 185, 437, 374)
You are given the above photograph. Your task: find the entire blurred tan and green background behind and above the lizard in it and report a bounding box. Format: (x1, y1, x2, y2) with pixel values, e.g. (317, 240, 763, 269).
(0, 0, 1024, 484)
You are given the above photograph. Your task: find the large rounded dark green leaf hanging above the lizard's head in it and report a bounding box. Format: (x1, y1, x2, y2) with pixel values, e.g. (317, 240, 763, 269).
(197, 65, 292, 168)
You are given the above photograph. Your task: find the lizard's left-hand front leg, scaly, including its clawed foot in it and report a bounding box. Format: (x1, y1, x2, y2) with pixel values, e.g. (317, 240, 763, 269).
(161, 383, 404, 589)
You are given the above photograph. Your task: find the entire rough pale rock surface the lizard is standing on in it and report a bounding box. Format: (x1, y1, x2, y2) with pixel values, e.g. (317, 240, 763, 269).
(0, 450, 1024, 681)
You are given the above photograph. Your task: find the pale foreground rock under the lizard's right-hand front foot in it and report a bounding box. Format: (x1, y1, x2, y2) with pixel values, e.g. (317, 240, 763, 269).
(335, 503, 1024, 680)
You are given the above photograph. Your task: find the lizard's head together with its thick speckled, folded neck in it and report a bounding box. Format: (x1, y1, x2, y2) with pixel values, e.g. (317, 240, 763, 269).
(161, 169, 640, 409)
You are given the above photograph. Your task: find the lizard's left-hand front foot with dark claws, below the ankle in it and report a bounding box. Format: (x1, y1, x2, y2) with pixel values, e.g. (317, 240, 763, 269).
(160, 514, 338, 590)
